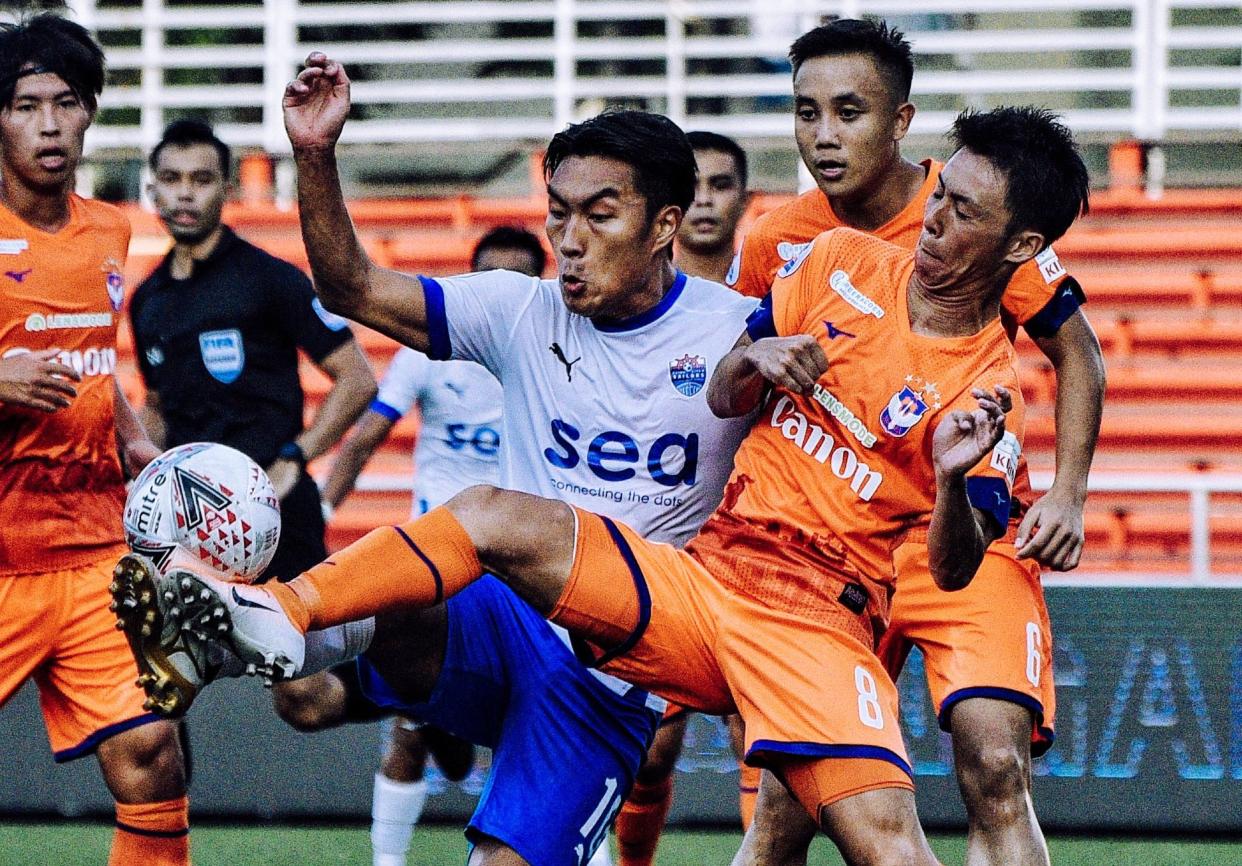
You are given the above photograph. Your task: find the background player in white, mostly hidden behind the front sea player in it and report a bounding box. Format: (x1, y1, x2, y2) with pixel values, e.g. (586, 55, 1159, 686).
(322, 226, 548, 866)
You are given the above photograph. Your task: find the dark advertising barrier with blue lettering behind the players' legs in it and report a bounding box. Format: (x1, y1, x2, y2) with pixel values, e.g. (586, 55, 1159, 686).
(0, 585, 1242, 835)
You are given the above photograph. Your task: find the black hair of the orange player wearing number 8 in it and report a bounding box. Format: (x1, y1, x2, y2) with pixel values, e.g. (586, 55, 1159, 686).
(949, 106, 1090, 244)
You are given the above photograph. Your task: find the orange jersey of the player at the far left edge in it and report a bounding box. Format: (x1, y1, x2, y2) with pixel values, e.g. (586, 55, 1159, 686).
(0, 195, 130, 574)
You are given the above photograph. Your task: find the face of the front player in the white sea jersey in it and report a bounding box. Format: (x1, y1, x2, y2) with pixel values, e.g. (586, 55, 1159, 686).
(546, 157, 681, 319)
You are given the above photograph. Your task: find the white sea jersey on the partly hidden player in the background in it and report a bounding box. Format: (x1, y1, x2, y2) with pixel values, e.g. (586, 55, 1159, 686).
(371, 348, 503, 514)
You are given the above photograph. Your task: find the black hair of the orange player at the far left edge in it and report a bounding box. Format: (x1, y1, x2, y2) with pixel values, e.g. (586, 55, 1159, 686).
(0, 12, 104, 112)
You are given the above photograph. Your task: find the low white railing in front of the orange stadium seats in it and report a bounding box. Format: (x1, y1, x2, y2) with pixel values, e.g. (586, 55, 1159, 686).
(342, 472, 1242, 586)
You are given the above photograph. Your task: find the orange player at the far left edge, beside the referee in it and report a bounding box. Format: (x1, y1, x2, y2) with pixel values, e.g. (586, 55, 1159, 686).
(0, 15, 189, 866)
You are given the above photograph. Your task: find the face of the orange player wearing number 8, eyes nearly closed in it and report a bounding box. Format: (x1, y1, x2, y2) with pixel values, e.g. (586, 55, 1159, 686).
(914, 150, 1012, 289)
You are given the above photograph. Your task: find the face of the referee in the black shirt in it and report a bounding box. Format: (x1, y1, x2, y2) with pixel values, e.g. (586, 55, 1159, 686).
(147, 143, 229, 244)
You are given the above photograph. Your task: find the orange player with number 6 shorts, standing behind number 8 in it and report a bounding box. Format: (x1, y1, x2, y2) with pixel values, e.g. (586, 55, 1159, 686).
(734, 20, 1104, 866)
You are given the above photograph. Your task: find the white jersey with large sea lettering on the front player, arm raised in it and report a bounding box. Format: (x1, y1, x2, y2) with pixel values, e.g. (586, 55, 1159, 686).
(422, 271, 758, 547)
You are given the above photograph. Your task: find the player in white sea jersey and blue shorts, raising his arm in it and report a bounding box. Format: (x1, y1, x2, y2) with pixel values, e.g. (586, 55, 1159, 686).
(118, 53, 755, 866)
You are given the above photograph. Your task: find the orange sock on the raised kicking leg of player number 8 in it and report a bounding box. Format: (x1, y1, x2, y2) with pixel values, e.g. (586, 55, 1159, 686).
(266, 506, 483, 631)
